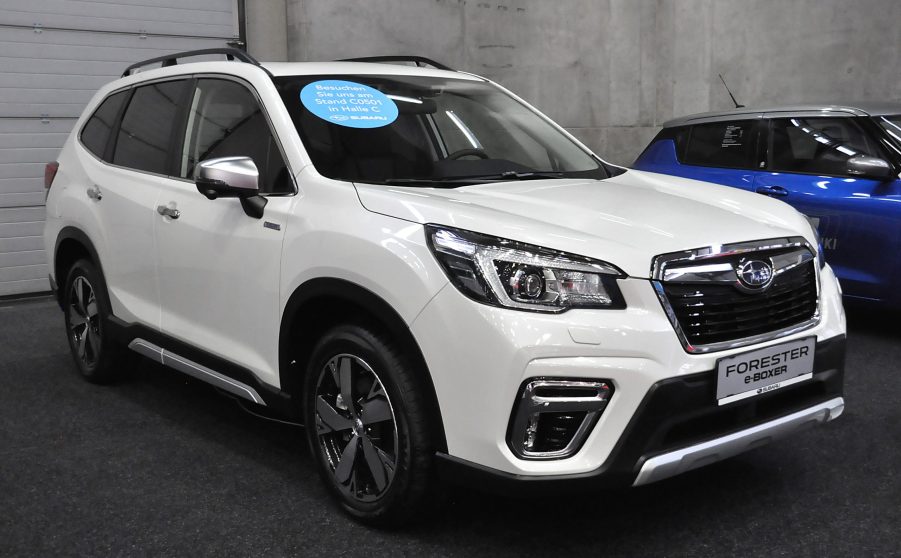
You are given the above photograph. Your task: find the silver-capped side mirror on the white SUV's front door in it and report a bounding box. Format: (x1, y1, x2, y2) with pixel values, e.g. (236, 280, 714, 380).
(194, 157, 267, 219)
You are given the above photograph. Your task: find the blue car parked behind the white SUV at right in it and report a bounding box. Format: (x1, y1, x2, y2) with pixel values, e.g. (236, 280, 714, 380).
(633, 103, 901, 308)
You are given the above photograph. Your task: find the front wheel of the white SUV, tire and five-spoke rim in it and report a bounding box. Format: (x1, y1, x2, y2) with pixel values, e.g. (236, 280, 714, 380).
(304, 325, 436, 527)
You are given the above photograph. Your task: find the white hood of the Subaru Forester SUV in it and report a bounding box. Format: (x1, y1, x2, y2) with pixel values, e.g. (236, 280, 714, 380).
(356, 170, 816, 278)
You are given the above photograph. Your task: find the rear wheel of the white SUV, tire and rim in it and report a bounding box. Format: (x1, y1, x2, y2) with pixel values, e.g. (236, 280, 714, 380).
(63, 260, 124, 384)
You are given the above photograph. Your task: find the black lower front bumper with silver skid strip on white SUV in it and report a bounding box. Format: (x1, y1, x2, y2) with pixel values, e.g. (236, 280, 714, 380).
(438, 335, 845, 494)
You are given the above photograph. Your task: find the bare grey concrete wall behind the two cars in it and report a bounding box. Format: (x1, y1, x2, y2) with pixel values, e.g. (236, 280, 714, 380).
(247, 0, 901, 164)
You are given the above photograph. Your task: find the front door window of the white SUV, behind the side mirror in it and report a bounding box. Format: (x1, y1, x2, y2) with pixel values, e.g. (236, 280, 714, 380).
(180, 79, 293, 192)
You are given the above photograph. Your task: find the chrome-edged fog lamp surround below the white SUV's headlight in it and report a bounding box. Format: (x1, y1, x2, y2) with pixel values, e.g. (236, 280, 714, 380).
(507, 378, 613, 459)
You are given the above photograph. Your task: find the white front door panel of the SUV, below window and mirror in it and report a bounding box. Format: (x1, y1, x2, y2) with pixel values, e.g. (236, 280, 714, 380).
(153, 180, 284, 385)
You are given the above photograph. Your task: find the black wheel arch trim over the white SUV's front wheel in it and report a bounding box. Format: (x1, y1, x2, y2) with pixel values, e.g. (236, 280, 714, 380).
(278, 278, 447, 452)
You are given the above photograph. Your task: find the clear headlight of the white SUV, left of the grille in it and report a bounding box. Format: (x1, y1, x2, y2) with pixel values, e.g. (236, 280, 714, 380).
(426, 225, 626, 312)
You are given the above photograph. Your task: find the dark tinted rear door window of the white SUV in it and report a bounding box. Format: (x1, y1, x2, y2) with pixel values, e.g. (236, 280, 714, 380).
(113, 80, 186, 174)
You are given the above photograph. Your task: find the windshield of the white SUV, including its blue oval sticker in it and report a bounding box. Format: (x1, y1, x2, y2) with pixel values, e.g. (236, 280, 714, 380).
(276, 75, 608, 187)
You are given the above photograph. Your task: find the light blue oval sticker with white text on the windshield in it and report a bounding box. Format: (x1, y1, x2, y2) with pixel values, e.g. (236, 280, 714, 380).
(300, 79, 397, 128)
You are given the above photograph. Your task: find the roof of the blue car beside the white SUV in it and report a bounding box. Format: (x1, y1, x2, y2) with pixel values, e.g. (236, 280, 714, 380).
(663, 101, 901, 128)
